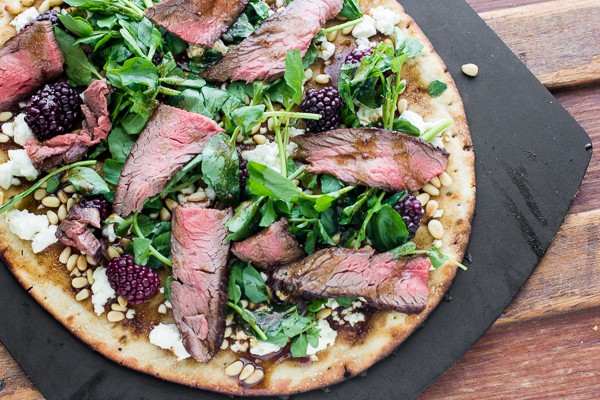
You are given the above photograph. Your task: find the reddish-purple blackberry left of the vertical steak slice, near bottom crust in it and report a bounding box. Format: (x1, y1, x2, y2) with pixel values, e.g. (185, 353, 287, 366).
(106, 254, 160, 305)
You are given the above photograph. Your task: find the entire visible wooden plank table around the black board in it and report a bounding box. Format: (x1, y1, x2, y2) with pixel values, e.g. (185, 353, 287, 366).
(0, 0, 600, 400)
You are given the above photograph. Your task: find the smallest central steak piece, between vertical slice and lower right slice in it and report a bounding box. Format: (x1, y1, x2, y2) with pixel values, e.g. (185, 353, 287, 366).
(231, 218, 304, 270)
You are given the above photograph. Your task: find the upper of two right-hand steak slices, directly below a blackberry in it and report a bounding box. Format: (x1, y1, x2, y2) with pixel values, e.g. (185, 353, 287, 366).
(293, 128, 449, 191)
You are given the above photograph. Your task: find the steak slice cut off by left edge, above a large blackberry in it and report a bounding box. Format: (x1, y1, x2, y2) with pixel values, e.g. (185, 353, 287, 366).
(0, 21, 63, 110)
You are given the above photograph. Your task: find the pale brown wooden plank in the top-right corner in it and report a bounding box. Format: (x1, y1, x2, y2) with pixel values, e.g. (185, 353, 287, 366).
(481, 0, 600, 88)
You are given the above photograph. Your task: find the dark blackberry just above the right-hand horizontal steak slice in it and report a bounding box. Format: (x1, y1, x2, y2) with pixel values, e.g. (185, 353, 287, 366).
(300, 86, 342, 132)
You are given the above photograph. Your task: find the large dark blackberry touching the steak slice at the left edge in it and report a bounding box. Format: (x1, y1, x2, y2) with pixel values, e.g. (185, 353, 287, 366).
(25, 82, 81, 141)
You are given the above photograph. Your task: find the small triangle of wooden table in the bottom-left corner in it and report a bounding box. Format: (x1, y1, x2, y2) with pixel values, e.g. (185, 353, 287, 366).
(0, 343, 44, 400)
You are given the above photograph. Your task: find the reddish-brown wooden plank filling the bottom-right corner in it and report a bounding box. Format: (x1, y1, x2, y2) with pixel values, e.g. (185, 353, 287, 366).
(419, 308, 600, 400)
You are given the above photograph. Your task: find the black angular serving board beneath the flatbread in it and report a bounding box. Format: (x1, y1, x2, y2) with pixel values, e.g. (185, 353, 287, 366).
(0, 0, 591, 400)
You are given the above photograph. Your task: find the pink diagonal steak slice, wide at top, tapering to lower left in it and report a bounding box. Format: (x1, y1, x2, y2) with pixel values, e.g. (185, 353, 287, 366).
(114, 104, 223, 217)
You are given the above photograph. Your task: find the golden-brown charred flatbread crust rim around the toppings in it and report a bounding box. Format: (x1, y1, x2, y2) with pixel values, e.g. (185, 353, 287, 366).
(0, 0, 475, 396)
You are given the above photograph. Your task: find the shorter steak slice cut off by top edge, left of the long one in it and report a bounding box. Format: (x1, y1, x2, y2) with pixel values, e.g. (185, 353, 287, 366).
(144, 0, 248, 47)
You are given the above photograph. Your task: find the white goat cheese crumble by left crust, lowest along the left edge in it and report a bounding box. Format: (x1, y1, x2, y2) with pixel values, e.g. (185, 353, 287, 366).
(6, 210, 58, 253)
